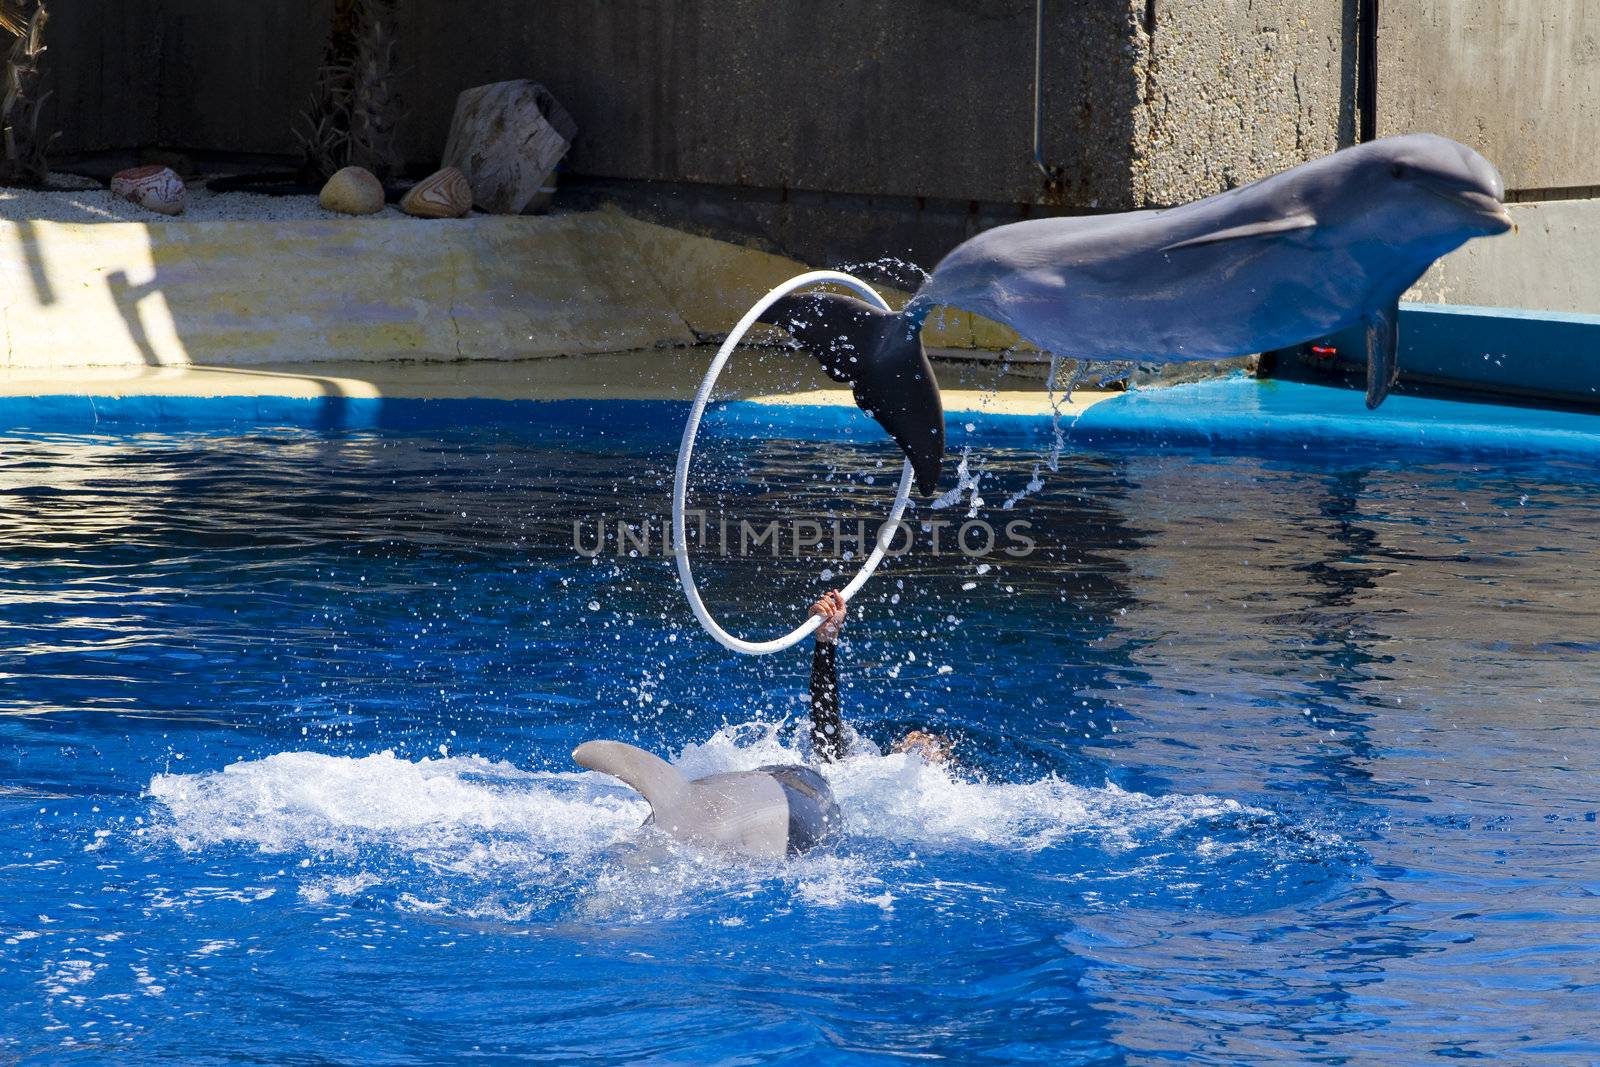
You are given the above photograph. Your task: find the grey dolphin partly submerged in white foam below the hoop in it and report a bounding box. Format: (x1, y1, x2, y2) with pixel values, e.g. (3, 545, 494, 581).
(573, 741, 843, 859)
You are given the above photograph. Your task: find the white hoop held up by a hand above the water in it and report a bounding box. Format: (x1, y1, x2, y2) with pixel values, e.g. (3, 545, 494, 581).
(672, 270, 912, 656)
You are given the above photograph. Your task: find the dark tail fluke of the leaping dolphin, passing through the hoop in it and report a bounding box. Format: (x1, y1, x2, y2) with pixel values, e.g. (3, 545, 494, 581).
(762, 293, 944, 496)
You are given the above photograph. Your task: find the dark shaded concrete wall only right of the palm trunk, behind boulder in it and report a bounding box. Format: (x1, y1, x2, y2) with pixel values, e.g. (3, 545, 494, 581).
(402, 0, 1136, 205)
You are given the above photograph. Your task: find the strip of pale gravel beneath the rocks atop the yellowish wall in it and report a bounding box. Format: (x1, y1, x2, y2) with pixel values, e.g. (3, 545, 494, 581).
(0, 174, 410, 222)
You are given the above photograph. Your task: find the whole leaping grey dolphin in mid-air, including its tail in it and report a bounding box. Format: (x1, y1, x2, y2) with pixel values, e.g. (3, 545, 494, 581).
(763, 133, 1512, 494)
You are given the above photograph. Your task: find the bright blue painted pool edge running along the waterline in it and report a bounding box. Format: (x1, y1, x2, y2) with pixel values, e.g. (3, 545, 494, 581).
(0, 376, 1600, 461)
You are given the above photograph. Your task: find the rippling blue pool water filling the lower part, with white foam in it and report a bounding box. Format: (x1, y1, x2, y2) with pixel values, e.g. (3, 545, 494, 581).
(0, 386, 1600, 1064)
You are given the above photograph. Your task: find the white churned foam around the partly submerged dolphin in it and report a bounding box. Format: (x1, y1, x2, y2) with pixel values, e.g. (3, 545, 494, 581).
(144, 720, 1331, 921)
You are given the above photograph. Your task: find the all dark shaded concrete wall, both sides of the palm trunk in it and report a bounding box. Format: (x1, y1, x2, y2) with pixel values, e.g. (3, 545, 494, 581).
(48, 0, 1136, 203)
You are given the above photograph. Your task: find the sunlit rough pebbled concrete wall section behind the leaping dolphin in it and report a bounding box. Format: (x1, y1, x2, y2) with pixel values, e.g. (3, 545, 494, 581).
(1130, 0, 1355, 205)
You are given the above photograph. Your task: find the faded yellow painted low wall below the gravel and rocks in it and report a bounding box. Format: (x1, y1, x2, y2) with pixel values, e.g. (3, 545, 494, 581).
(0, 211, 1014, 370)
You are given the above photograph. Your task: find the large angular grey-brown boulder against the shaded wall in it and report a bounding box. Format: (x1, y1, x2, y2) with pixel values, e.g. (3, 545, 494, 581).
(445, 80, 578, 214)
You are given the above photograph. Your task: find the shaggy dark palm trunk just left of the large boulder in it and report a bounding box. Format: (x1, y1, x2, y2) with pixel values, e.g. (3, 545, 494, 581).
(294, 0, 400, 182)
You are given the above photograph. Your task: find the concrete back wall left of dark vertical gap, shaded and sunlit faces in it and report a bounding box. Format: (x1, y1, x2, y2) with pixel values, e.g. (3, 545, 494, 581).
(48, 0, 1350, 210)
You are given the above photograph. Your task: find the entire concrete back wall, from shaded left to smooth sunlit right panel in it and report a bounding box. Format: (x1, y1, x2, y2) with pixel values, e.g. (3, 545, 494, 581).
(34, 0, 1600, 310)
